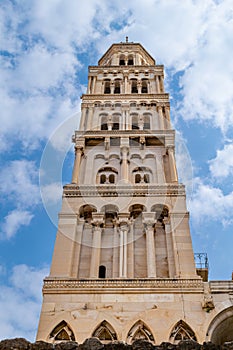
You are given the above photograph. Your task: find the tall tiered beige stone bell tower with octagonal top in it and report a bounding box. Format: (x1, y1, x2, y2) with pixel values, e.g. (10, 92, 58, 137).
(37, 40, 233, 343)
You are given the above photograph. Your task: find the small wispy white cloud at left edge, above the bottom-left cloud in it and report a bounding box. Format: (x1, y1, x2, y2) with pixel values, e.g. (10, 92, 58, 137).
(1, 209, 33, 239)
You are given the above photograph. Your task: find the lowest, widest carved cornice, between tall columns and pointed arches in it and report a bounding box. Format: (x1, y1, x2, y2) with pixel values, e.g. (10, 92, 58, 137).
(43, 277, 204, 294)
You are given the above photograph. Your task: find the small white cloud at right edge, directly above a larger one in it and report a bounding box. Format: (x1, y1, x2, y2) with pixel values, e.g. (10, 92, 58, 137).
(209, 143, 233, 178)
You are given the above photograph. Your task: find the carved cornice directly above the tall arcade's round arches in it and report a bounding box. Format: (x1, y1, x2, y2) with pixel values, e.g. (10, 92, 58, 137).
(63, 184, 185, 197)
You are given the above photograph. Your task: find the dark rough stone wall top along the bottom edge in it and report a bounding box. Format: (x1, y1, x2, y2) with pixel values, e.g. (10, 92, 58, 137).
(0, 338, 233, 350)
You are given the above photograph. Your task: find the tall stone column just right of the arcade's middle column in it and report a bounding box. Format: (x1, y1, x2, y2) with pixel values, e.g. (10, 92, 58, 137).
(142, 213, 156, 278)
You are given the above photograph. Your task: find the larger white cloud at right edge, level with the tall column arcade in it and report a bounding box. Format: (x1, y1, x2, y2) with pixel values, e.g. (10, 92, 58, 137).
(189, 178, 233, 225)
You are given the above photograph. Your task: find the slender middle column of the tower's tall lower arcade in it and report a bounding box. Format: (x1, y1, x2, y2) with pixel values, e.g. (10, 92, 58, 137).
(118, 213, 129, 278)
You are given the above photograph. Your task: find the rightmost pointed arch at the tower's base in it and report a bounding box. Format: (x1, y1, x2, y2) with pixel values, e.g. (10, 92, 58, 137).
(169, 320, 197, 344)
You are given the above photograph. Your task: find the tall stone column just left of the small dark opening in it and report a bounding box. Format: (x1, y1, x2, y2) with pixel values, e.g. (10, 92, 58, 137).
(90, 213, 104, 278)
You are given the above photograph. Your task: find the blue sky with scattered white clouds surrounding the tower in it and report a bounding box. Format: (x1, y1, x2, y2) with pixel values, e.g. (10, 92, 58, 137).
(0, 0, 233, 340)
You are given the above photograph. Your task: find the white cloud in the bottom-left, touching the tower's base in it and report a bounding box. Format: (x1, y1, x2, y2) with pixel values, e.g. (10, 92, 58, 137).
(0, 265, 48, 341)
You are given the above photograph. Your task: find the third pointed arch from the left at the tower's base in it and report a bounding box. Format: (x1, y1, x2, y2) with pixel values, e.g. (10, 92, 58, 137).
(126, 320, 155, 344)
